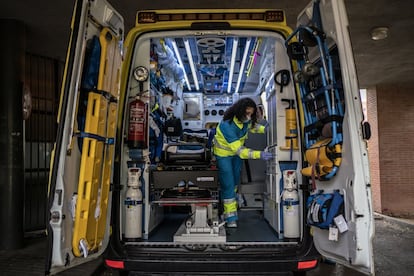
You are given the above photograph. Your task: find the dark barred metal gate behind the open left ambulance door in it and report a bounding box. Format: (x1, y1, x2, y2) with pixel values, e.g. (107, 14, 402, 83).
(24, 54, 64, 232)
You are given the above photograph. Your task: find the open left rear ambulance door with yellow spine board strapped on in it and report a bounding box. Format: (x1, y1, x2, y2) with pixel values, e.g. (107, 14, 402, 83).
(46, 0, 124, 274)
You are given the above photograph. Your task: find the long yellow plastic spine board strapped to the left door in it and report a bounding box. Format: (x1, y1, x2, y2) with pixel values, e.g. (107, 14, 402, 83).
(72, 28, 121, 257)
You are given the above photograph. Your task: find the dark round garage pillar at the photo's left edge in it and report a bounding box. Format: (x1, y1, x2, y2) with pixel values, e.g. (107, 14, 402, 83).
(0, 19, 26, 250)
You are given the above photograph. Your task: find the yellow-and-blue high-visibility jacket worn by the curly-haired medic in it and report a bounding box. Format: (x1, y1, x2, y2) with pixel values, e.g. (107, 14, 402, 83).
(213, 117, 265, 159)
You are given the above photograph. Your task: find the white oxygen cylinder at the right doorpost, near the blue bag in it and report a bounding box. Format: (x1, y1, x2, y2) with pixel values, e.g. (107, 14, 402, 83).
(282, 170, 300, 239)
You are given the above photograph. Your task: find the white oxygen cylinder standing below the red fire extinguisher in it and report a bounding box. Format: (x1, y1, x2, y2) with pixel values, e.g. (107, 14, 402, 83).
(124, 168, 142, 239)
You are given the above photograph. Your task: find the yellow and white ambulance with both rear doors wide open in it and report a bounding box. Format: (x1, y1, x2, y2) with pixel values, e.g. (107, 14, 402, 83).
(46, 0, 374, 275)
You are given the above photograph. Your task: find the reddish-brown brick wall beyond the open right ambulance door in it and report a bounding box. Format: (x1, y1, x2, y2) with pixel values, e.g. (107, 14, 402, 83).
(373, 85, 414, 218)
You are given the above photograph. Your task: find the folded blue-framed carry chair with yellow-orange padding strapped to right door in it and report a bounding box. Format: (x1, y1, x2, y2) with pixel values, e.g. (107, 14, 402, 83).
(286, 1, 345, 180)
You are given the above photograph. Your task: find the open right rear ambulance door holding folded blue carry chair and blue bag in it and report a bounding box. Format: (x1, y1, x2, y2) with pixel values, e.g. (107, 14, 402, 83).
(286, 0, 374, 275)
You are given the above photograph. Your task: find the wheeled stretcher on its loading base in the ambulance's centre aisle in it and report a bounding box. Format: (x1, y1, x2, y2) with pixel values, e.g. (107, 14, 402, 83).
(151, 126, 226, 243)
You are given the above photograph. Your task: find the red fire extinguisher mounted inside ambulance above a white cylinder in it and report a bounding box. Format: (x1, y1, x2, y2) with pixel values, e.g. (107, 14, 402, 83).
(128, 97, 148, 149)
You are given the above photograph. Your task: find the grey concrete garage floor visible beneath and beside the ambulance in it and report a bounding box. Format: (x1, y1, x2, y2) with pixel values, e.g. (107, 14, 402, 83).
(0, 215, 414, 276)
